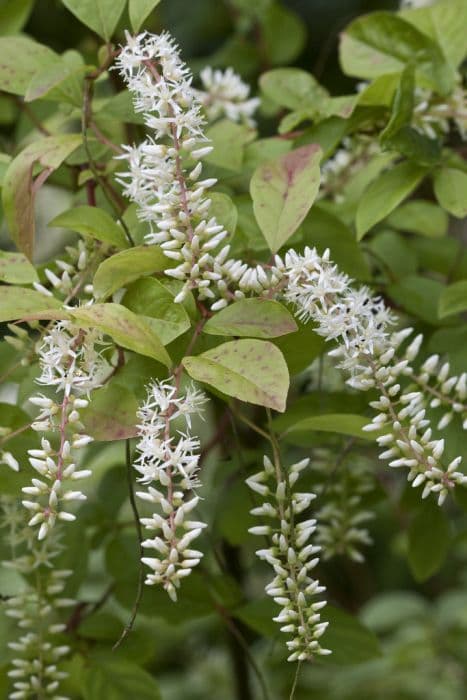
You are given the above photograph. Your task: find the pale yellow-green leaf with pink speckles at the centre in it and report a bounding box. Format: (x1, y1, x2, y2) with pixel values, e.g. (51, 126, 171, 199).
(182, 340, 289, 411)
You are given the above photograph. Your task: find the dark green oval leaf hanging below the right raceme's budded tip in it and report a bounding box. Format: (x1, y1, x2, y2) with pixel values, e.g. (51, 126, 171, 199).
(407, 502, 451, 581)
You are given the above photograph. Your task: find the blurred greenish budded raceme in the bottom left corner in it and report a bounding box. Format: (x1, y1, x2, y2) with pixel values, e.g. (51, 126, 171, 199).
(1, 498, 75, 700)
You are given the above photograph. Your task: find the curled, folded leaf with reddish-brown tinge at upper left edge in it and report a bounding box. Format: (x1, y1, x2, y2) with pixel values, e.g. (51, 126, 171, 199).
(2, 134, 81, 259)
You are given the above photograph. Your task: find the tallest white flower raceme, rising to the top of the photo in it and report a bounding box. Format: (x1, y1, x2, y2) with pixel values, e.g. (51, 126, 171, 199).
(117, 33, 232, 301)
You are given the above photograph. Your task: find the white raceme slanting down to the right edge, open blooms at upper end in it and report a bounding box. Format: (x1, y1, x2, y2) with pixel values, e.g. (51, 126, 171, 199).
(285, 248, 467, 504)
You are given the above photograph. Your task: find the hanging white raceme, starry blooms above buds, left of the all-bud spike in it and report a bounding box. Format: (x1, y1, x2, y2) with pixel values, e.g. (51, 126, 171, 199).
(134, 378, 205, 601)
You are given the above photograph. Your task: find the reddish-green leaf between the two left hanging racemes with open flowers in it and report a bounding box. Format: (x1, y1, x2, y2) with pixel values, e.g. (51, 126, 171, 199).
(80, 381, 138, 441)
